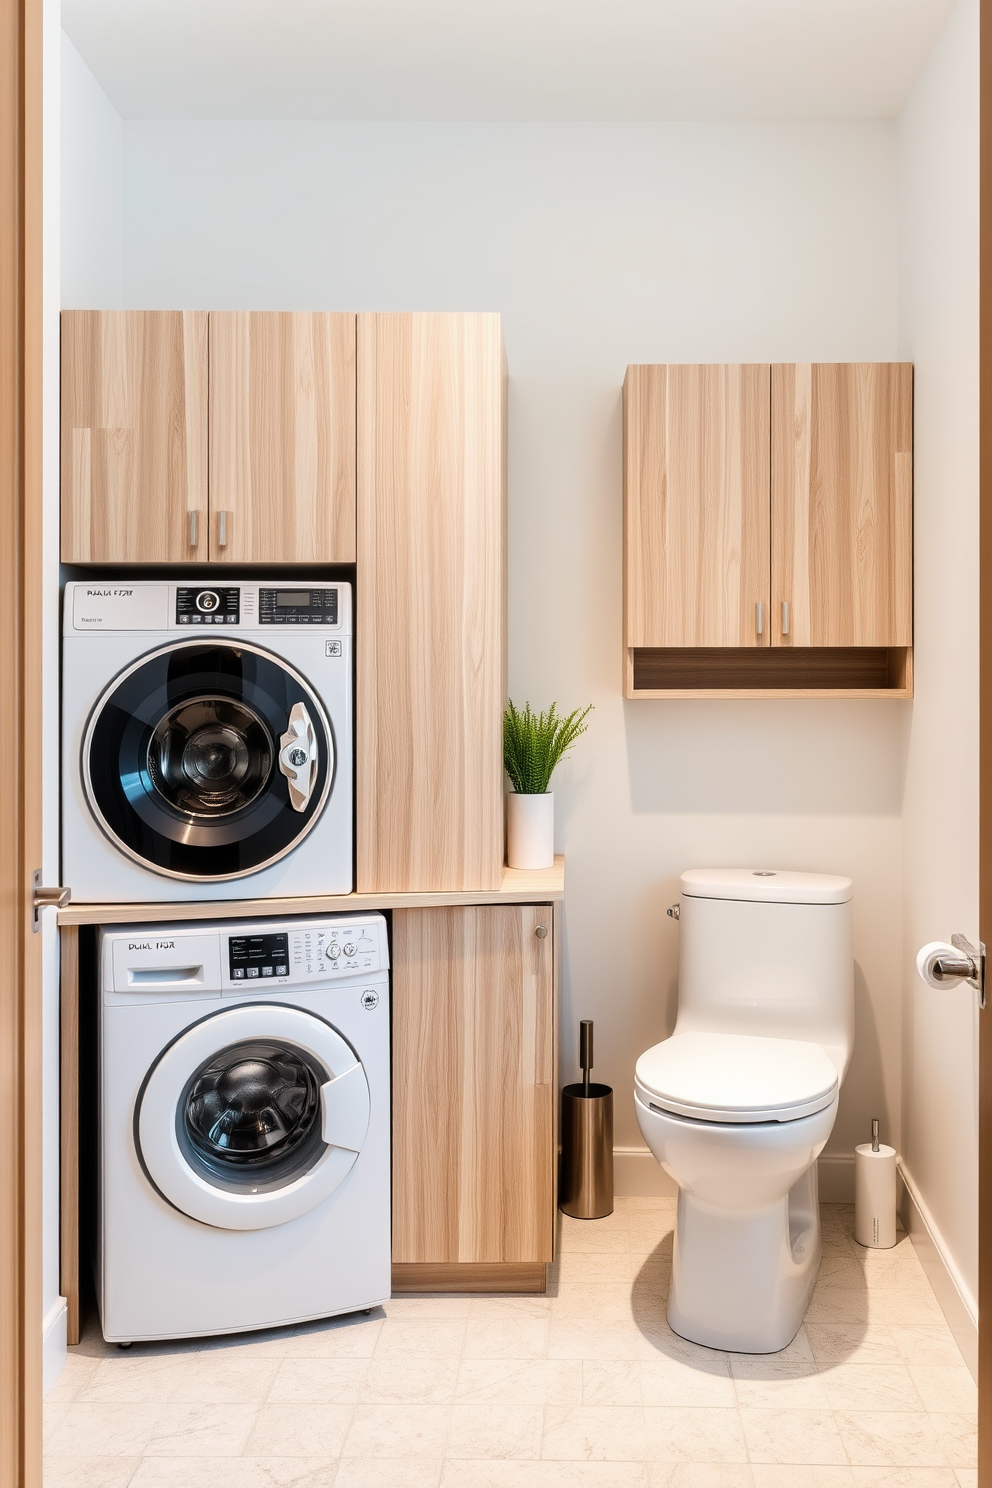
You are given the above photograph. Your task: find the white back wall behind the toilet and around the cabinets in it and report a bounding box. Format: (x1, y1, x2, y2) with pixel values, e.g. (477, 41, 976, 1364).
(123, 122, 906, 1152)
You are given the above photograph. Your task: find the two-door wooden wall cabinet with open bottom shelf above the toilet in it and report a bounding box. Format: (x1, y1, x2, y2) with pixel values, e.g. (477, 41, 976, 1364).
(623, 363, 913, 698)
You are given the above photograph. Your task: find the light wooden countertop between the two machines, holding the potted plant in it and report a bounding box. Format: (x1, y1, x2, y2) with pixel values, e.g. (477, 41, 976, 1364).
(58, 853, 565, 926)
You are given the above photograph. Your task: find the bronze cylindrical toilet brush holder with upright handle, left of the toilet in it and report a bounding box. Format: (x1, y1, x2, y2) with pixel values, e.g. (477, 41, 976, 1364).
(558, 1018, 613, 1219)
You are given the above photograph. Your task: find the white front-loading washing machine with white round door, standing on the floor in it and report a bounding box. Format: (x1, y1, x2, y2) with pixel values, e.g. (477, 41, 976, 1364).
(95, 914, 391, 1342)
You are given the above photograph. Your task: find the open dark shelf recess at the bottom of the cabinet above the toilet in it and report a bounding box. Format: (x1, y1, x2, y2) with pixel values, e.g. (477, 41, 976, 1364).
(626, 646, 913, 698)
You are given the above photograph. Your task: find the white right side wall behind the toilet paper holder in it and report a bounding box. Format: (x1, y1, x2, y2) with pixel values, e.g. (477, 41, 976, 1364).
(898, 0, 992, 1318)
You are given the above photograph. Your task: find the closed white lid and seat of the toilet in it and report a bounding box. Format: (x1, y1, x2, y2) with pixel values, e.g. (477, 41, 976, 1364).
(635, 1033, 837, 1122)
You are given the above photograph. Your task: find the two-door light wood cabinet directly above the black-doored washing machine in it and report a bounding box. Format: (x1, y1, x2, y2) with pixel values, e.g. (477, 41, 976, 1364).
(62, 311, 355, 564)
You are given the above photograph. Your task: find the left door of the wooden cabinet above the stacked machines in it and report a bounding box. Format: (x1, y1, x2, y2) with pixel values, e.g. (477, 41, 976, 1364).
(62, 310, 207, 562)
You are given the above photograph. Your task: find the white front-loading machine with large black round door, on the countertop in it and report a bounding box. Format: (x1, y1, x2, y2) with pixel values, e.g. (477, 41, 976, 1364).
(62, 579, 354, 903)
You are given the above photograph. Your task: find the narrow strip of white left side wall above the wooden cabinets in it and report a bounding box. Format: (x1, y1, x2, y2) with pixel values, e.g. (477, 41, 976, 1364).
(61, 33, 123, 310)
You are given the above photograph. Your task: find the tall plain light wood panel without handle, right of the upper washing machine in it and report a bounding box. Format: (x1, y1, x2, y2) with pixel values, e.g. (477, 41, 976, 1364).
(355, 314, 506, 893)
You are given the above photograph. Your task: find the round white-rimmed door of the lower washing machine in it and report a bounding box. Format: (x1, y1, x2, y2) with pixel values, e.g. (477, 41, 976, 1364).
(134, 1003, 370, 1229)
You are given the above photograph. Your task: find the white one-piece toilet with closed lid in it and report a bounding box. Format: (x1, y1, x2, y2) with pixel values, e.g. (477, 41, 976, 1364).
(634, 869, 854, 1354)
